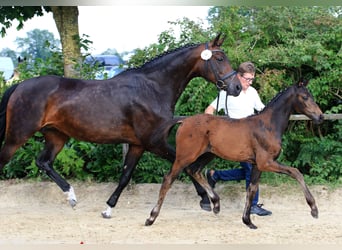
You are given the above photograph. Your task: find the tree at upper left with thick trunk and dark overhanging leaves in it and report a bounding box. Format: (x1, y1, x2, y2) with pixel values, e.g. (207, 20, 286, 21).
(0, 6, 81, 77)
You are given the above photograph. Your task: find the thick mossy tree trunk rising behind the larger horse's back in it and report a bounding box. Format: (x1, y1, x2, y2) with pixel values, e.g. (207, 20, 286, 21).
(51, 6, 81, 78)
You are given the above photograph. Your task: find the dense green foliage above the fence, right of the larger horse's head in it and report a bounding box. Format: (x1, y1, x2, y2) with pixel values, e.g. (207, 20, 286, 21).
(208, 6, 342, 110)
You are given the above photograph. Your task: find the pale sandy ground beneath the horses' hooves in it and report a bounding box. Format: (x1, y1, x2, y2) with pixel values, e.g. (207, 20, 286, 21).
(0, 181, 342, 245)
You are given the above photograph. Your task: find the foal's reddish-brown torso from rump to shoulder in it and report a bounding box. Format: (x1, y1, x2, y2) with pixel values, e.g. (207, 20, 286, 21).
(176, 114, 271, 165)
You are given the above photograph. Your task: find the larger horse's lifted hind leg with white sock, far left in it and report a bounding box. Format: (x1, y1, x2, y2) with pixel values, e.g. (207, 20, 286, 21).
(36, 129, 77, 207)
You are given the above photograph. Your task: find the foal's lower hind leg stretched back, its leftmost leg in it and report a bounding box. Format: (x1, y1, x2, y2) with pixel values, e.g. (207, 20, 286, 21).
(145, 164, 181, 226)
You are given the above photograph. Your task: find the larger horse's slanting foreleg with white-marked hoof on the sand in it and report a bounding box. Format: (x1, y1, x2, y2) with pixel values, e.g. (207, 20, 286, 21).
(102, 145, 144, 218)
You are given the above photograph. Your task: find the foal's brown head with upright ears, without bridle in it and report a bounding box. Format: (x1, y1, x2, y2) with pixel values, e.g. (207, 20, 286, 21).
(293, 81, 324, 124)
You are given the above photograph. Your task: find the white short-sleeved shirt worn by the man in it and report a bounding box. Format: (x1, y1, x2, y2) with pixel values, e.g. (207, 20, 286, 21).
(210, 86, 265, 119)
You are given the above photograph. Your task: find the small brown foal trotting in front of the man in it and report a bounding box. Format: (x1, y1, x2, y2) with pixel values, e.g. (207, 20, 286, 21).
(145, 82, 324, 228)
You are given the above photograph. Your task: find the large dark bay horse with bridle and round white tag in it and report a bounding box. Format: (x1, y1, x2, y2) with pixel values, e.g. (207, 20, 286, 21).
(0, 34, 241, 218)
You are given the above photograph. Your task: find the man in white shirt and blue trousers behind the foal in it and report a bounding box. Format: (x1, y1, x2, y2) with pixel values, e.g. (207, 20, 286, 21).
(201, 62, 272, 216)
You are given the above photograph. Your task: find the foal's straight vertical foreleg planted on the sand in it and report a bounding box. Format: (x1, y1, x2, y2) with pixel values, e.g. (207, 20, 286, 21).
(242, 166, 261, 229)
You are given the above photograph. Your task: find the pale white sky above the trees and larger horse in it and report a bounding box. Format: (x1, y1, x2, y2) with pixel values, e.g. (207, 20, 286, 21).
(0, 5, 209, 54)
